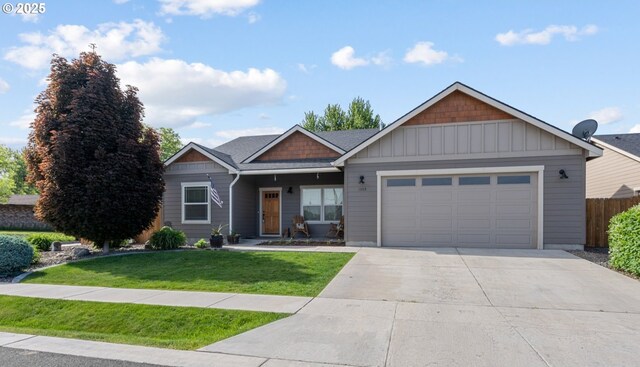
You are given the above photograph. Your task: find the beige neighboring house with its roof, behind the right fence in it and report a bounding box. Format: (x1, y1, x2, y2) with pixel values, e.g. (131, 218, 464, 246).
(587, 134, 640, 198)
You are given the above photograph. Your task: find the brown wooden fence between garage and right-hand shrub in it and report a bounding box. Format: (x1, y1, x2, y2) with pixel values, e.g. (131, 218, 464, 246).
(586, 197, 640, 247)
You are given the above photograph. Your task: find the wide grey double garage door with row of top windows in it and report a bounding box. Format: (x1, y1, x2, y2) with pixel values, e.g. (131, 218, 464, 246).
(381, 173, 537, 248)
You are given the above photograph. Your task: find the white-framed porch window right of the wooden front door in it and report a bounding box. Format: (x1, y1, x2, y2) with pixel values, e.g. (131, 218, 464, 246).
(301, 187, 343, 222)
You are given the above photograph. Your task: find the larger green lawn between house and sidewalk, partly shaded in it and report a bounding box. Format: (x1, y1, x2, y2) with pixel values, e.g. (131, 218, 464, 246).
(23, 251, 353, 297)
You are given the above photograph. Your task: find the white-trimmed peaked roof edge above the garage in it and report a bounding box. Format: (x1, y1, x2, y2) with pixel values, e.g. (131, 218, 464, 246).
(333, 82, 602, 166)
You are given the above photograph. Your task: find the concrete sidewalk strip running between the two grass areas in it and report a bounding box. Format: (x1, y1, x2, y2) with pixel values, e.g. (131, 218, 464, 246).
(0, 283, 312, 313)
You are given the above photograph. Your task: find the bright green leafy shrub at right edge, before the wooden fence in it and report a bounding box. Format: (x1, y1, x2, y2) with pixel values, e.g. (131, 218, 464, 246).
(609, 205, 640, 275)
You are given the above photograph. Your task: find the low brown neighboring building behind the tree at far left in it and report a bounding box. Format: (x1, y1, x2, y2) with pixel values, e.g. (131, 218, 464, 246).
(0, 195, 51, 230)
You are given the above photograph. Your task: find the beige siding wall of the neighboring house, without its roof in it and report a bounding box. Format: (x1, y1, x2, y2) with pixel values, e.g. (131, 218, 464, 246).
(587, 147, 640, 199)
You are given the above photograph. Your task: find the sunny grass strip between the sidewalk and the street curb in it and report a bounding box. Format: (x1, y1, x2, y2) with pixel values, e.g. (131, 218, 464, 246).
(0, 296, 288, 350)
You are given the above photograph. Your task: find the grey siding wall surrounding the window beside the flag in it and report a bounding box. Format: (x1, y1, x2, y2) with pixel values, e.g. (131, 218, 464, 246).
(162, 161, 234, 243)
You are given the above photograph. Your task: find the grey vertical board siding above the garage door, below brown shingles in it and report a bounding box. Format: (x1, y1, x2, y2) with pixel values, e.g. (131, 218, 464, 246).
(350, 120, 582, 163)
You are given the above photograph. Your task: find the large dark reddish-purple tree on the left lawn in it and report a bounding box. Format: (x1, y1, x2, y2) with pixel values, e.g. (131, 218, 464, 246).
(26, 53, 164, 252)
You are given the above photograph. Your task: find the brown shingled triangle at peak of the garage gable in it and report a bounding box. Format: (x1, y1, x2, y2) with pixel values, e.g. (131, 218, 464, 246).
(404, 91, 515, 126)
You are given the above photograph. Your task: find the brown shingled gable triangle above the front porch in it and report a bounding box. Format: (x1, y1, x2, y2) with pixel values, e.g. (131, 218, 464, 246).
(256, 131, 340, 162)
